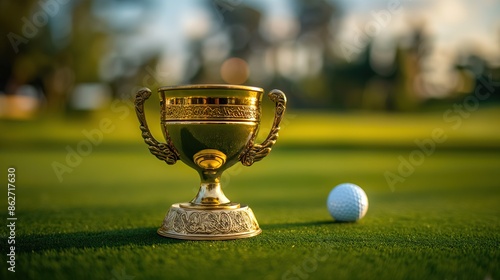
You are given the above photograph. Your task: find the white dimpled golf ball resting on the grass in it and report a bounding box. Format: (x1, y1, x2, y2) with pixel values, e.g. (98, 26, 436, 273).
(326, 183, 368, 222)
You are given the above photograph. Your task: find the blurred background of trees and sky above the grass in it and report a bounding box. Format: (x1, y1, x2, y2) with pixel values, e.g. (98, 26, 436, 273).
(0, 0, 500, 119)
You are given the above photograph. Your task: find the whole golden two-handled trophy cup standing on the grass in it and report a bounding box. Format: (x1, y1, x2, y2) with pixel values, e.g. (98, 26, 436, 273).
(135, 84, 286, 240)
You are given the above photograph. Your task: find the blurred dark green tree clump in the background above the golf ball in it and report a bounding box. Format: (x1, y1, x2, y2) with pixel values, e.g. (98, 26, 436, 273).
(326, 23, 429, 111)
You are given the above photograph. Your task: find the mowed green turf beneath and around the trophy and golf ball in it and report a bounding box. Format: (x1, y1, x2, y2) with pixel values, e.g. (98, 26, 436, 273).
(0, 111, 500, 280)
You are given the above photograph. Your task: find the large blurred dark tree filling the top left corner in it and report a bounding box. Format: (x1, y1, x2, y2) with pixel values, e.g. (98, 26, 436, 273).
(0, 0, 109, 114)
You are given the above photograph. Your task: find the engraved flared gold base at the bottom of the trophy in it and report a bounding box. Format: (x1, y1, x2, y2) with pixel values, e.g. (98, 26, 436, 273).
(158, 203, 262, 240)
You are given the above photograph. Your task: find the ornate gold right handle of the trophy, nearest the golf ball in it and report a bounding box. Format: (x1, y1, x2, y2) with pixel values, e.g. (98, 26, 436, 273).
(240, 89, 286, 166)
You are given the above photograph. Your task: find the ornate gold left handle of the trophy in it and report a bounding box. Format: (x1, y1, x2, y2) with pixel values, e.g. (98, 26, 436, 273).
(134, 88, 179, 164)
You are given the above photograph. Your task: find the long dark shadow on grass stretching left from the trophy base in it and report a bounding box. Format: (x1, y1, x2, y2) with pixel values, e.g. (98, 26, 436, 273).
(16, 227, 186, 253)
